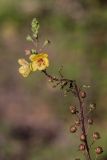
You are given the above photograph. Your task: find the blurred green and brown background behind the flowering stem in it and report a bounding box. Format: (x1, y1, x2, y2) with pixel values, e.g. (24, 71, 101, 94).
(0, 0, 107, 160)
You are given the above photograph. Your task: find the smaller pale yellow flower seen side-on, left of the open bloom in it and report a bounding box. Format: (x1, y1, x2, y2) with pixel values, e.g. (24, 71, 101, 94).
(18, 58, 31, 77)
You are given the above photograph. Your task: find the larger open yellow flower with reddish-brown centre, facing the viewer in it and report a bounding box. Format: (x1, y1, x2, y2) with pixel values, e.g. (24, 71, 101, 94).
(29, 53, 49, 71)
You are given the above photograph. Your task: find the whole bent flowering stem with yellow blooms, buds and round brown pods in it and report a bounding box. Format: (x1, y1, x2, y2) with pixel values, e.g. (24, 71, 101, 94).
(18, 18, 103, 160)
